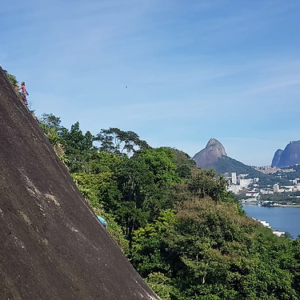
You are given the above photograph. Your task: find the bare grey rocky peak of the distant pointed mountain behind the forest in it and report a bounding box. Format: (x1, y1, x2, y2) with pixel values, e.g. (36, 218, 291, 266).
(193, 138, 227, 168)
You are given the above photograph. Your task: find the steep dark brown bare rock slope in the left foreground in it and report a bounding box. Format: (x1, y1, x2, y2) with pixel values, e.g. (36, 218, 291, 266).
(0, 67, 159, 300)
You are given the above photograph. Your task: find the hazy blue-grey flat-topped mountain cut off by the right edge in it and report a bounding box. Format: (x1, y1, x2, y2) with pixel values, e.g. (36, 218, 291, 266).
(272, 141, 300, 168)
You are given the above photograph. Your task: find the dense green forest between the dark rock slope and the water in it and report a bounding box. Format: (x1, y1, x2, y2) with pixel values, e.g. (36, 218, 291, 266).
(7, 73, 300, 300)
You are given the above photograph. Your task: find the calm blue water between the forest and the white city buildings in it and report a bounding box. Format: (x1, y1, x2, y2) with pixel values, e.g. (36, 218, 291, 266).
(243, 205, 300, 239)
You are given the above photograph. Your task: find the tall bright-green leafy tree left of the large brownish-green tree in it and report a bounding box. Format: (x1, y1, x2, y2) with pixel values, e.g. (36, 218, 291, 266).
(115, 148, 180, 245)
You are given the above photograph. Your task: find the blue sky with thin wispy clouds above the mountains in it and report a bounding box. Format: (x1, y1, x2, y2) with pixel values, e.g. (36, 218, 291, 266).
(0, 0, 300, 166)
